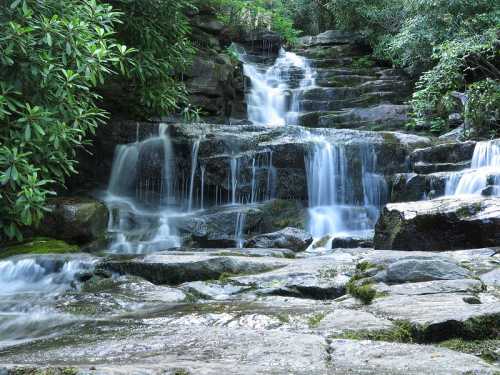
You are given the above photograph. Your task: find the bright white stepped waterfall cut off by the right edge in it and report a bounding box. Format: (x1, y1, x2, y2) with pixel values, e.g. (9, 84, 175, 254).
(445, 140, 500, 196)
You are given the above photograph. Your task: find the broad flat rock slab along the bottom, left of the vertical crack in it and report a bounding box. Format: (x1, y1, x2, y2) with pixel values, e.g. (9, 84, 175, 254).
(0, 326, 327, 375)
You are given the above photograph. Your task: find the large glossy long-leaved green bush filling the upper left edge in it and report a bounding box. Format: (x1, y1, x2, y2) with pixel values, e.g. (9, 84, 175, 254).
(0, 0, 132, 240)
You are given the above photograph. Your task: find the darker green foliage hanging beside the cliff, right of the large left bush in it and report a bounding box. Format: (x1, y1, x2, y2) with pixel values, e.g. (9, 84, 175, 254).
(107, 0, 194, 116)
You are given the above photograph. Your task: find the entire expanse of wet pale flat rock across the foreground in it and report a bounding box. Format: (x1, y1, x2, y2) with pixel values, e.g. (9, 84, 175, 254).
(0, 248, 500, 375)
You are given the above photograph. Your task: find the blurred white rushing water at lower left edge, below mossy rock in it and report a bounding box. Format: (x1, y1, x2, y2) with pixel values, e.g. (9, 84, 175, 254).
(0, 257, 94, 348)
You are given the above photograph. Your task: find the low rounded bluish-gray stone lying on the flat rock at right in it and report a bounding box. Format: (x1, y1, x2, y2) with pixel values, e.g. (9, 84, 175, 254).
(386, 257, 471, 284)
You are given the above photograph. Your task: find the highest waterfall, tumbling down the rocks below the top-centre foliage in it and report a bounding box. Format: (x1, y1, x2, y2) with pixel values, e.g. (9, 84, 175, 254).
(240, 49, 316, 126)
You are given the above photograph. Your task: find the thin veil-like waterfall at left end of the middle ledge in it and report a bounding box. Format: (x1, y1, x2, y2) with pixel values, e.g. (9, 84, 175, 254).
(104, 124, 182, 253)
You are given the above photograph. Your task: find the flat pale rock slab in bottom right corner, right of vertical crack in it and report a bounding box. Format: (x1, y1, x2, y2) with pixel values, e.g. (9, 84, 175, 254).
(330, 340, 498, 375)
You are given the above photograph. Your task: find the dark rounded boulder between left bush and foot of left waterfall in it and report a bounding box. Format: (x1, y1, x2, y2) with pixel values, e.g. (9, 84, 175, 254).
(38, 197, 108, 243)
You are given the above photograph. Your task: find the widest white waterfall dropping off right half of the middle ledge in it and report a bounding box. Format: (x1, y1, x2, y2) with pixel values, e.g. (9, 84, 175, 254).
(306, 141, 387, 238)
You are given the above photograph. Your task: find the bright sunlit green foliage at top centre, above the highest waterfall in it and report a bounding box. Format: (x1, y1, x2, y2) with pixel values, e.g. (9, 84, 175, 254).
(212, 0, 299, 43)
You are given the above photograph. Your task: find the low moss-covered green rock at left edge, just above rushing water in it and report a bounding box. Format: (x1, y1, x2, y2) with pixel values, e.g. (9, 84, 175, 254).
(0, 238, 80, 259)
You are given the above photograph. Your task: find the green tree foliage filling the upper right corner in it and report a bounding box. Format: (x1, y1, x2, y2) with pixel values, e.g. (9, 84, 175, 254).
(328, 0, 500, 137)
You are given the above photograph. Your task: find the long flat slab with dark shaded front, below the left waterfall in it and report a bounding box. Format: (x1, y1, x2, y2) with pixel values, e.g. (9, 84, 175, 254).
(101, 252, 289, 285)
